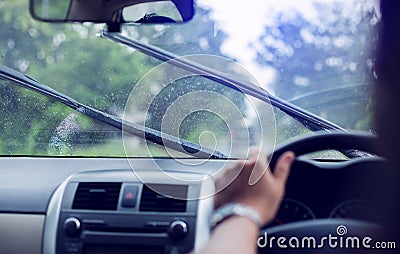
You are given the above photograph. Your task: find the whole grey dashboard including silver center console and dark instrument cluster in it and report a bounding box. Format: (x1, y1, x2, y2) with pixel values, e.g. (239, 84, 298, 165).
(0, 157, 385, 254)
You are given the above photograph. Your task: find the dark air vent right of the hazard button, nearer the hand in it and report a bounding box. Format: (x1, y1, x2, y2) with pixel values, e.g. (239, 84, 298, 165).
(139, 185, 187, 213)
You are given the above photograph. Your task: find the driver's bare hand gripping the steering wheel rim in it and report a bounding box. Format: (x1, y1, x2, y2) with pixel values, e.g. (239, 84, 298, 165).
(214, 148, 295, 223)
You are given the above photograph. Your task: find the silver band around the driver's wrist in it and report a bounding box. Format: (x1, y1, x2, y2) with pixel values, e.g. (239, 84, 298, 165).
(210, 203, 263, 229)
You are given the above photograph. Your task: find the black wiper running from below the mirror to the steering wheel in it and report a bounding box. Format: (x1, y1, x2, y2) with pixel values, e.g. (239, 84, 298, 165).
(100, 30, 347, 132)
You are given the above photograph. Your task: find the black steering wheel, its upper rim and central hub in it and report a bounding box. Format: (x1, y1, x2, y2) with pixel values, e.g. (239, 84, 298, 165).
(258, 132, 390, 253)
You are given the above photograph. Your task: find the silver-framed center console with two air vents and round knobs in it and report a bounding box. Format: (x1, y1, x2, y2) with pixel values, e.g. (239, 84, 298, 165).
(43, 170, 213, 254)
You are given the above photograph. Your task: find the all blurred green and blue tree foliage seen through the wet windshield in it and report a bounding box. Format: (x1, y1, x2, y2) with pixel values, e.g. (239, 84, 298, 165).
(0, 0, 374, 156)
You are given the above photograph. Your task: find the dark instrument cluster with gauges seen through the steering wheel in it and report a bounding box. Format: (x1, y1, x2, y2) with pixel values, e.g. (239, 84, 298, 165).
(268, 158, 384, 226)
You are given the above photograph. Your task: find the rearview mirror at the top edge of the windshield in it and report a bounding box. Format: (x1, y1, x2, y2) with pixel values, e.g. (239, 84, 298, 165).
(30, 0, 194, 24)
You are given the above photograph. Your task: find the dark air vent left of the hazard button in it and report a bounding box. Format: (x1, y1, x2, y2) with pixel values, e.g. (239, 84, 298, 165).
(72, 182, 121, 210)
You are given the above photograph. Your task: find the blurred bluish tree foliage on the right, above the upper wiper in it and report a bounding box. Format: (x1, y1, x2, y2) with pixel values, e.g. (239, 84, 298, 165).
(253, 1, 377, 131)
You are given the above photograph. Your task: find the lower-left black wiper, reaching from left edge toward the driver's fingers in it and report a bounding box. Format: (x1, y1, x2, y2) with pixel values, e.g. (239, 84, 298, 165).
(0, 66, 226, 159)
